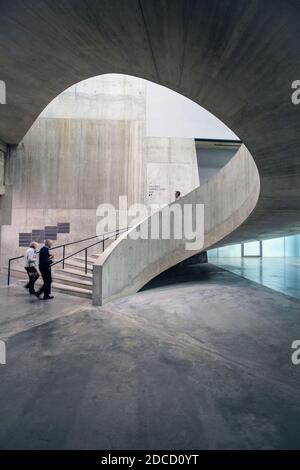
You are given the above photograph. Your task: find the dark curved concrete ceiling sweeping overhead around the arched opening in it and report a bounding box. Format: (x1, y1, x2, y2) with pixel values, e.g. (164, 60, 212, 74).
(0, 0, 300, 242)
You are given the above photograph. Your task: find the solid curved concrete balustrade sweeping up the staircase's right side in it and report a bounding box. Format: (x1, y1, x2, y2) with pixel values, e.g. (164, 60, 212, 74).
(93, 146, 260, 305)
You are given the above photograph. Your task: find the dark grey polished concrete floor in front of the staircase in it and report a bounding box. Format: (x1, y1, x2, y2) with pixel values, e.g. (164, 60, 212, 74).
(0, 265, 300, 450)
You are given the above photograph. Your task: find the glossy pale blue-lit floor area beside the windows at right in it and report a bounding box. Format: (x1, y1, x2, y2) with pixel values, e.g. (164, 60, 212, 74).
(211, 257, 300, 299)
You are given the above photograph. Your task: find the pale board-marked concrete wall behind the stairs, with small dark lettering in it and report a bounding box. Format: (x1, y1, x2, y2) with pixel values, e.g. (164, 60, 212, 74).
(1, 74, 199, 267)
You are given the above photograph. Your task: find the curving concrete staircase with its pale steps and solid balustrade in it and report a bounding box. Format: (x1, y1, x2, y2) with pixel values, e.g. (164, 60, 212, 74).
(7, 145, 260, 305)
